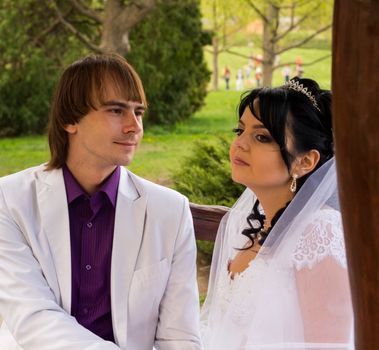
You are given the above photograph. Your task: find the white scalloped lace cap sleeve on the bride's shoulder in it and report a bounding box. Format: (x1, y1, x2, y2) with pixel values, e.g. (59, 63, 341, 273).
(293, 208, 347, 270)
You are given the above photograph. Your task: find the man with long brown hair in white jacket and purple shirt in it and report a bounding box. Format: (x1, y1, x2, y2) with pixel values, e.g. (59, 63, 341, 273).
(0, 55, 201, 350)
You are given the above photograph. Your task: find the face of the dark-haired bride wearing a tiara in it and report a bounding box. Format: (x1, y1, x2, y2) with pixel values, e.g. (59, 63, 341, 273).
(230, 100, 291, 192)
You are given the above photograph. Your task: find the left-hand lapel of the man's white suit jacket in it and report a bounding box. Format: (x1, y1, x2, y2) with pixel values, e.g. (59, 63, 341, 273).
(36, 169, 71, 313)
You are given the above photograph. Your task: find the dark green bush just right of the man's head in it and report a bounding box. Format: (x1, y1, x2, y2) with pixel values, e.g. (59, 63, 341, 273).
(127, 0, 211, 124)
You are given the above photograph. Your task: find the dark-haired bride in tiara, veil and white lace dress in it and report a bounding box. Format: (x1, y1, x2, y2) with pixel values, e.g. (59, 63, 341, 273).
(202, 78, 352, 350)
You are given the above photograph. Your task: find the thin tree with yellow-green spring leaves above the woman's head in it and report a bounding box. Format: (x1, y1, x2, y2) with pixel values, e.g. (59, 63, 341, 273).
(246, 0, 333, 86)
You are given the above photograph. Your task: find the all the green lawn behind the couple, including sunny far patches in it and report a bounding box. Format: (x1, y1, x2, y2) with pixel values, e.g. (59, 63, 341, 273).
(0, 48, 331, 186)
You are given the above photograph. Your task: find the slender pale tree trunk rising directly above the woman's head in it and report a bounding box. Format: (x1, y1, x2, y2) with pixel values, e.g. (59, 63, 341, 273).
(262, 2, 279, 86)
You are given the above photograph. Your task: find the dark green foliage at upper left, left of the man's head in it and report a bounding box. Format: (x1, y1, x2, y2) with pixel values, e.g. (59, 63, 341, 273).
(0, 0, 87, 137)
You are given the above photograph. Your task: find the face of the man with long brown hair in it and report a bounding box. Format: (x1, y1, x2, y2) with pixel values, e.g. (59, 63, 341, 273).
(66, 86, 145, 170)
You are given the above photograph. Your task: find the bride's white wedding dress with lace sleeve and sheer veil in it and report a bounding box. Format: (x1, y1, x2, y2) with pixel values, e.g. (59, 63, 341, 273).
(201, 160, 353, 350)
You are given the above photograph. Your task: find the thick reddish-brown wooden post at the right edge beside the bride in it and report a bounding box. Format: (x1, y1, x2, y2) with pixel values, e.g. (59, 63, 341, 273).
(333, 0, 379, 350)
